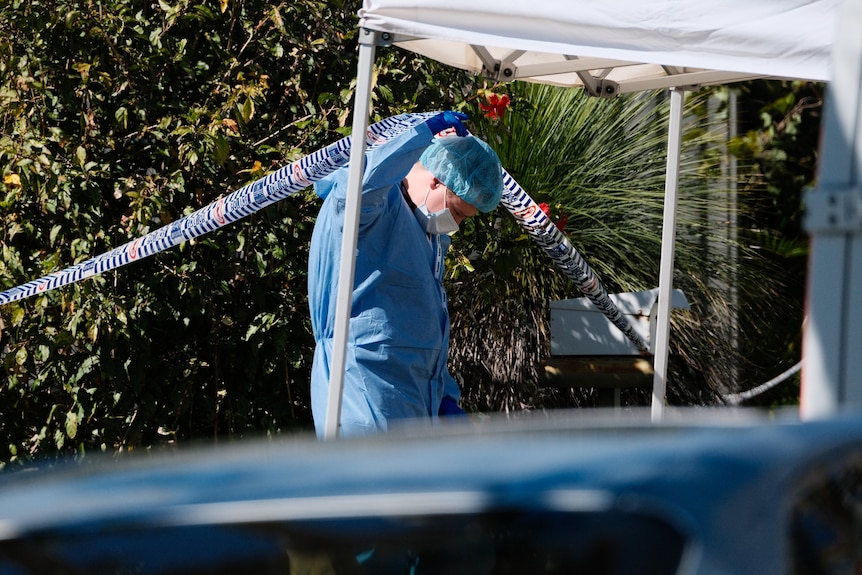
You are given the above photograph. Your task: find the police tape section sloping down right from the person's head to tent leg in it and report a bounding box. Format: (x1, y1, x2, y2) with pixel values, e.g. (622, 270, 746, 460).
(500, 170, 650, 354)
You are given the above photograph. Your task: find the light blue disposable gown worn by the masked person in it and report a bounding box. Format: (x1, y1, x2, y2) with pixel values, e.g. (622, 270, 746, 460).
(308, 124, 460, 437)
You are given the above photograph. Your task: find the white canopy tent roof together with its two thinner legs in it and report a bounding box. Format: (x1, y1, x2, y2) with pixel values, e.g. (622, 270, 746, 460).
(325, 0, 850, 437)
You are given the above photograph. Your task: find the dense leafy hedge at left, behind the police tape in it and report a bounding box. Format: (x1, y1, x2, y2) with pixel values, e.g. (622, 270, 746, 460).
(0, 0, 460, 462)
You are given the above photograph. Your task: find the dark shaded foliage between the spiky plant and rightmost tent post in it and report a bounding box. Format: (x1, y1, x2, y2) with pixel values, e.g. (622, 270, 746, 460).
(731, 80, 825, 405)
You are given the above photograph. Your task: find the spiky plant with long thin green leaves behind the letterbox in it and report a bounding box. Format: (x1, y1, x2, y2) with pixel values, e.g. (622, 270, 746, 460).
(449, 83, 791, 411)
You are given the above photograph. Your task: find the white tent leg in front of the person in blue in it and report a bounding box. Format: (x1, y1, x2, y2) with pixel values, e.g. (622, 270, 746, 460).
(323, 30, 376, 439)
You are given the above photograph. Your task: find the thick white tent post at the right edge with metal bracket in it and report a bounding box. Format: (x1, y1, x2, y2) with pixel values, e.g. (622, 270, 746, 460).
(799, 0, 862, 419)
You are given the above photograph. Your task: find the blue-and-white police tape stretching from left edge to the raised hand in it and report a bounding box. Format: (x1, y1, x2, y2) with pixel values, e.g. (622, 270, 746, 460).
(0, 112, 436, 305)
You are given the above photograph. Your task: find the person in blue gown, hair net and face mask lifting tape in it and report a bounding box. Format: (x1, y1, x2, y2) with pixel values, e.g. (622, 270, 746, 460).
(308, 112, 503, 437)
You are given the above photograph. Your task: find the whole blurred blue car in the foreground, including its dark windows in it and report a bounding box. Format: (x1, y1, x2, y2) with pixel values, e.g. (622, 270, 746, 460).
(0, 410, 862, 575)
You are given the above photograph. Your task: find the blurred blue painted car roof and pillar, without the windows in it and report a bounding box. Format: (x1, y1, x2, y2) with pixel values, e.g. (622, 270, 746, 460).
(0, 410, 862, 573)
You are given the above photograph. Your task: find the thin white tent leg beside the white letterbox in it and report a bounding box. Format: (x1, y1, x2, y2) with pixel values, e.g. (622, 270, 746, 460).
(652, 89, 683, 421)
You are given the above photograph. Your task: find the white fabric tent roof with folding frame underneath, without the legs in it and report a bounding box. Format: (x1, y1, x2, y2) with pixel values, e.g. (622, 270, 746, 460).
(359, 0, 839, 92)
